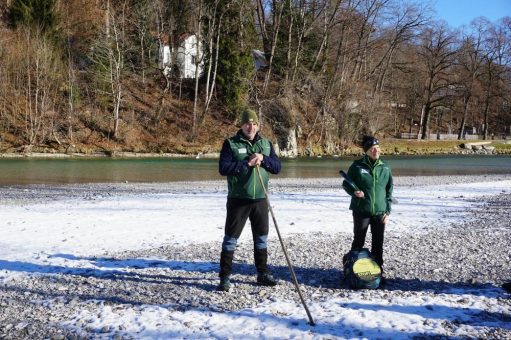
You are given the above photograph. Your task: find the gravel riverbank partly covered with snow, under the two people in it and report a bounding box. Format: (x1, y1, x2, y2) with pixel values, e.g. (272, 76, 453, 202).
(0, 176, 511, 339)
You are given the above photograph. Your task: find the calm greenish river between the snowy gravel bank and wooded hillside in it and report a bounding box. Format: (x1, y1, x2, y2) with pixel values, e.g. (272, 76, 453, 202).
(0, 155, 511, 185)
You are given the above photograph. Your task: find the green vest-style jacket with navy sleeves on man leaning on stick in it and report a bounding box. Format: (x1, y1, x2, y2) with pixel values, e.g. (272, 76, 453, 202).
(218, 130, 281, 200)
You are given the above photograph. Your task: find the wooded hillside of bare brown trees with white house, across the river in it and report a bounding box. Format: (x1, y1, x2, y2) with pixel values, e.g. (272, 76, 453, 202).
(0, 0, 511, 156)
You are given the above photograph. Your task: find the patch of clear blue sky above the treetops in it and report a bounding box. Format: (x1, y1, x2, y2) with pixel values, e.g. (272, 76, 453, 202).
(430, 0, 511, 28)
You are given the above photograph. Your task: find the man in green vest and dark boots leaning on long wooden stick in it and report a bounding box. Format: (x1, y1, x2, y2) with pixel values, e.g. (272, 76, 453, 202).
(218, 109, 281, 291)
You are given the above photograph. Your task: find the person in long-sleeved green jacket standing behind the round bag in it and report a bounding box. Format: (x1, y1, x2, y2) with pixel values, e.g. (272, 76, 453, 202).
(343, 136, 393, 269)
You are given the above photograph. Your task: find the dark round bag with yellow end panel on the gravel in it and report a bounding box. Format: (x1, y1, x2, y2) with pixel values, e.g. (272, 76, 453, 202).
(342, 248, 382, 289)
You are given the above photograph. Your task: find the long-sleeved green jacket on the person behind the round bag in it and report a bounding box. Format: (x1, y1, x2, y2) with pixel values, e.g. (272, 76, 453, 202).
(342, 155, 394, 216)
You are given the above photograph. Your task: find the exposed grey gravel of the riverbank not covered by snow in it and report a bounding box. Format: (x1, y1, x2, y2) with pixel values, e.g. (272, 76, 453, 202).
(0, 177, 511, 339)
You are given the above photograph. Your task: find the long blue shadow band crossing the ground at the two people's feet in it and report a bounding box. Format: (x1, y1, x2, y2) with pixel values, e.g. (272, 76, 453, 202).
(0, 254, 502, 297)
